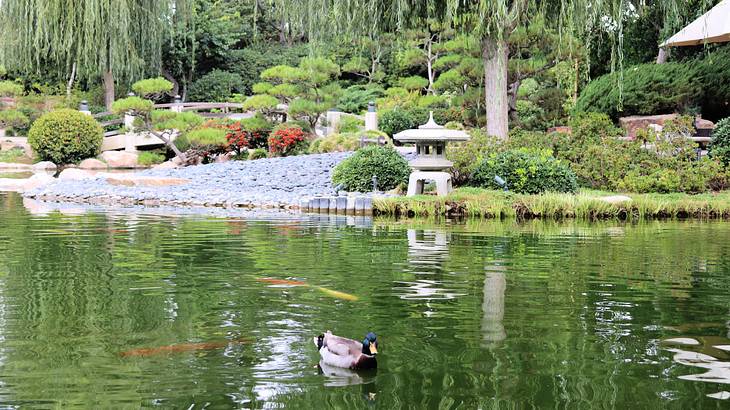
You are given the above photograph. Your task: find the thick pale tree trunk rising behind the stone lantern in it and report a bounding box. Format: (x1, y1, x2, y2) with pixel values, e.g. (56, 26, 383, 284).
(482, 38, 509, 139)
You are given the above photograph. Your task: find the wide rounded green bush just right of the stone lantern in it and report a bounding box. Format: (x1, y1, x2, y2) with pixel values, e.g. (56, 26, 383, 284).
(471, 150, 578, 194)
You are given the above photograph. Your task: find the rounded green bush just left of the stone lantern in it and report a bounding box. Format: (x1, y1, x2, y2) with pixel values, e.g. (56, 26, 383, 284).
(332, 145, 411, 192)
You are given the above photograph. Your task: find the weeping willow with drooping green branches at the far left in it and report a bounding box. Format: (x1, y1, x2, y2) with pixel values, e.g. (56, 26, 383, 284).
(0, 0, 192, 108)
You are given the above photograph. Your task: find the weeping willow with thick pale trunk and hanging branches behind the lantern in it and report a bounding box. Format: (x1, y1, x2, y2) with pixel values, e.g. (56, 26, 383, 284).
(270, 0, 717, 138)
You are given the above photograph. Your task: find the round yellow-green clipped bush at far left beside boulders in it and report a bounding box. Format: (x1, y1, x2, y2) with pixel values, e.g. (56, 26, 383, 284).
(28, 109, 104, 164)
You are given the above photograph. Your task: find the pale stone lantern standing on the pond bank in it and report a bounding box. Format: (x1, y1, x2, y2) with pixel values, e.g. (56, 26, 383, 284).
(394, 112, 469, 196)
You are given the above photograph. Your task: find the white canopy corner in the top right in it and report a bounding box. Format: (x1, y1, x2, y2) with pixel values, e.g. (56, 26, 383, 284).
(659, 0, 730, 49)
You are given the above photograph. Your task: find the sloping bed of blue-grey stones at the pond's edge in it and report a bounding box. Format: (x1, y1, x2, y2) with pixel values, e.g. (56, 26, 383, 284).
(25, 152, 370, 208)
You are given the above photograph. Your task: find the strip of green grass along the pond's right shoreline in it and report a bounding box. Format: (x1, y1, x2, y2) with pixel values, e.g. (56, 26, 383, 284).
(373, 188, 730, 220)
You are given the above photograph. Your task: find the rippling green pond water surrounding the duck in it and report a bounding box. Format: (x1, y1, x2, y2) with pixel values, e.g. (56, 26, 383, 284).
(0, 194, 730, 409)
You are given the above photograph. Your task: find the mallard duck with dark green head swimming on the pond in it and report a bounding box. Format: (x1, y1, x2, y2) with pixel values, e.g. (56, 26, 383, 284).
(314, 330, 378, 370)
